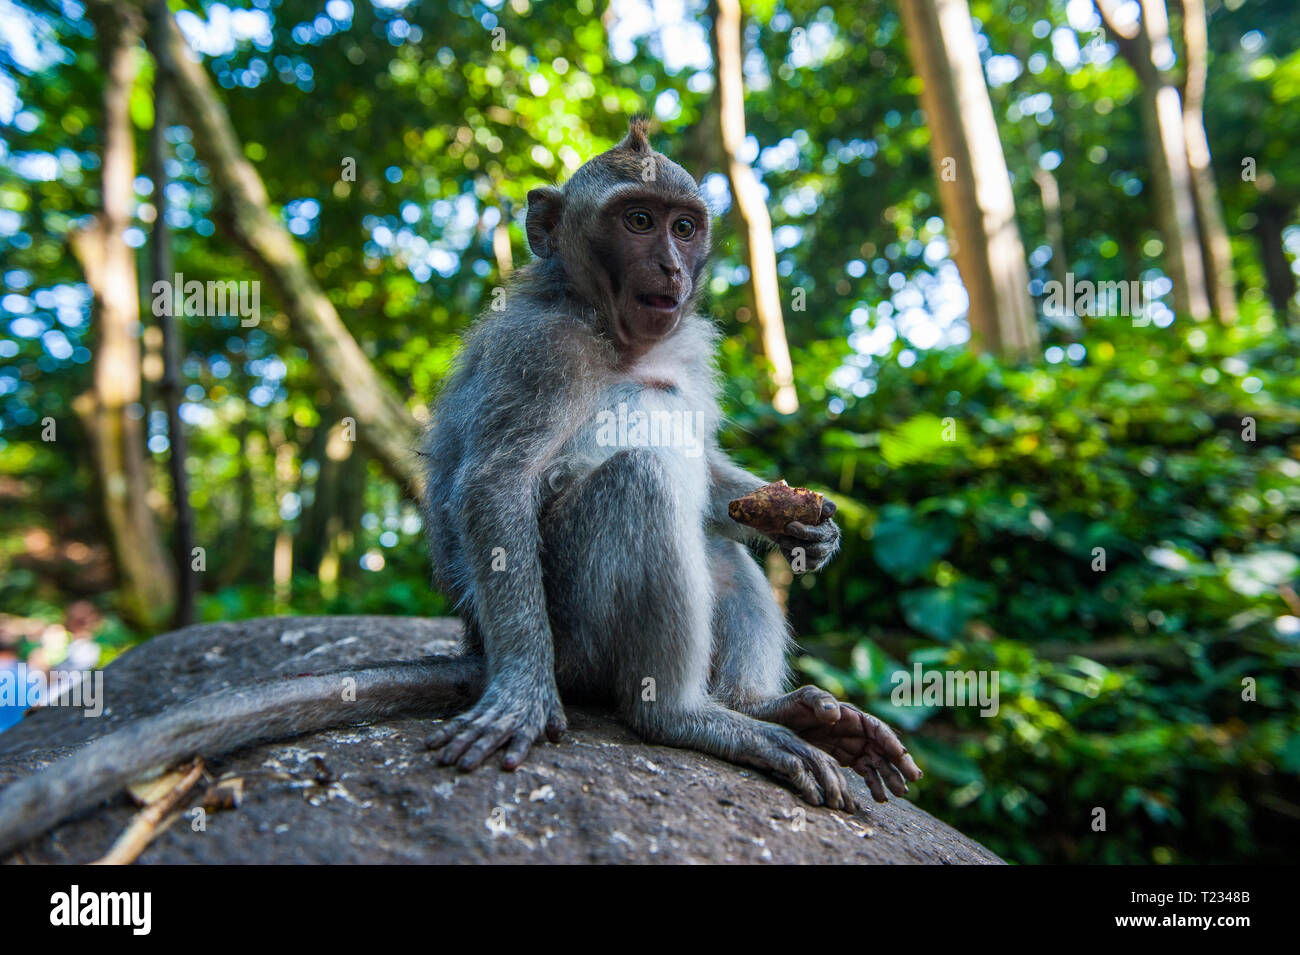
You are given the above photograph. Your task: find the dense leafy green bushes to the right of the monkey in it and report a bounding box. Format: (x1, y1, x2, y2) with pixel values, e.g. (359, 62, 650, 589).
(735, 322, 1300, 863)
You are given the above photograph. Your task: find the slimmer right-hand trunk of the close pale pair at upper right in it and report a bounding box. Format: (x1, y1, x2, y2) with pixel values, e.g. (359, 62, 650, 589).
(1182, 0, 1236, 324)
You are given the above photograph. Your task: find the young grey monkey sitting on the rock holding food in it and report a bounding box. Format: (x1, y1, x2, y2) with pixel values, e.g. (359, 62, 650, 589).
(0, 117, 922, 855)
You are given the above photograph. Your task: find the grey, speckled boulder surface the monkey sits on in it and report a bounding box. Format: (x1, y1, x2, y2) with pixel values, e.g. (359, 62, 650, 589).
(0, 617, 1000, 863)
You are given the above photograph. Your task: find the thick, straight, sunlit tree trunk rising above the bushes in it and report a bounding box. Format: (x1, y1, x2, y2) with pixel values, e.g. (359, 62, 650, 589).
(901, 0, 1039, 355)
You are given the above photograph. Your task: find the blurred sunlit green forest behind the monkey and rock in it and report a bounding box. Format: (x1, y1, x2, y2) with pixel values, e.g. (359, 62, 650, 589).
(0, 0, 1300, 863)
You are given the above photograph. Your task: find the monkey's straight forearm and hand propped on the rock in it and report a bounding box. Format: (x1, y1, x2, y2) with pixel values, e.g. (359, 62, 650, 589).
(428, 454, 566, 772)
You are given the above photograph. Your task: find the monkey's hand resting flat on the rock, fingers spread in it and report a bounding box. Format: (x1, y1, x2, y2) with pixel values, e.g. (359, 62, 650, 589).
(425, 677, 568, 772)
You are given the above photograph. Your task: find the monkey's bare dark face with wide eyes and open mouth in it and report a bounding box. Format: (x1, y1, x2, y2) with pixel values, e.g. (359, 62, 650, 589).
(601, 192, 709, 347)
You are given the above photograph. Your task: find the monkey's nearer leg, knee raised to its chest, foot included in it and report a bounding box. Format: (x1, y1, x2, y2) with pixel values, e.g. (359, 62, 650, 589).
(542, 450, 854, 811)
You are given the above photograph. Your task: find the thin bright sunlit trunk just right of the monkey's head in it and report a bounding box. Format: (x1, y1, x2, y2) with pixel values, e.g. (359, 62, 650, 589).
(711, 0, 800, 414)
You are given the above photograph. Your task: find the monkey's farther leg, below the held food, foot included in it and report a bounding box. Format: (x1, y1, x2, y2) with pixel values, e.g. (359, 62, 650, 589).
(710, 538, 922, 802)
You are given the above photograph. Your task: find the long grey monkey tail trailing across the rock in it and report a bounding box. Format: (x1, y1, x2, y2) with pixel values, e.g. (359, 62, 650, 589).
(0, 656, 484, 858)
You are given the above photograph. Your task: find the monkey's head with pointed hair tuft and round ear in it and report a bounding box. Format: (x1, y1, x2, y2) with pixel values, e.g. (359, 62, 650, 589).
(527, 117, 710, 352)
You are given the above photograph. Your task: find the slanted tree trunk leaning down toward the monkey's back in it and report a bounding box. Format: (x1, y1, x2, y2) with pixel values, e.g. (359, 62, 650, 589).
(148, 11, 424, 496)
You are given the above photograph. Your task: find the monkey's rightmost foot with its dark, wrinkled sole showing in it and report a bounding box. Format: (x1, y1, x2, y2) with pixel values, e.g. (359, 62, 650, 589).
(745, 686, 922, 803)
